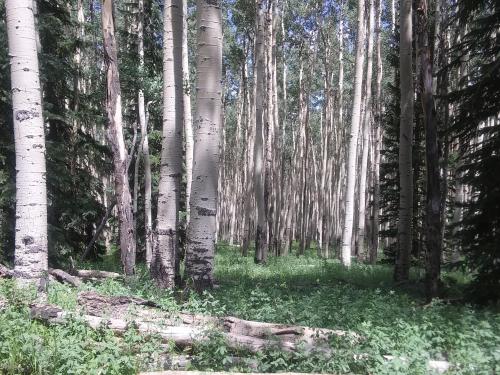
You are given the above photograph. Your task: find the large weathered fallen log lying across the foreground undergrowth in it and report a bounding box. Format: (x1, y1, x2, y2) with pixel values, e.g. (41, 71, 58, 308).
(31, 292, 450, 375)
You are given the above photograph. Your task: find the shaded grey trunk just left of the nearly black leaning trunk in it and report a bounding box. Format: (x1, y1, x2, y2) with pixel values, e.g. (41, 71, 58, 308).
(394, 0, 414, 282)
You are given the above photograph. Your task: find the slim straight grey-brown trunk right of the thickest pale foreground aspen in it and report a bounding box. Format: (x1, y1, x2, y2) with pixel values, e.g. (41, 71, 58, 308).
(254, 0, 267, 263)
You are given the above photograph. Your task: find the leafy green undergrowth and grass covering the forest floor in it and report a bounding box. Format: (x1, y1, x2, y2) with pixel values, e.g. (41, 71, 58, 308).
(0, 245, 500, 374)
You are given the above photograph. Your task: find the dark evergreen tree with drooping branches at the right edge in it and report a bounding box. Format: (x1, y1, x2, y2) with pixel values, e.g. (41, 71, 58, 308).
(450, 0, 500, 302)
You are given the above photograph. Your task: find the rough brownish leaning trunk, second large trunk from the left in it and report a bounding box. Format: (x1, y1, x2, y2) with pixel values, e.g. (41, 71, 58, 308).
(102, 0, 136, 276)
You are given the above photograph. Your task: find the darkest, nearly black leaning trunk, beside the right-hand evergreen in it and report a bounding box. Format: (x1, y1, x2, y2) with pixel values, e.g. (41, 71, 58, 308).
(418, 0, 442, 301)
